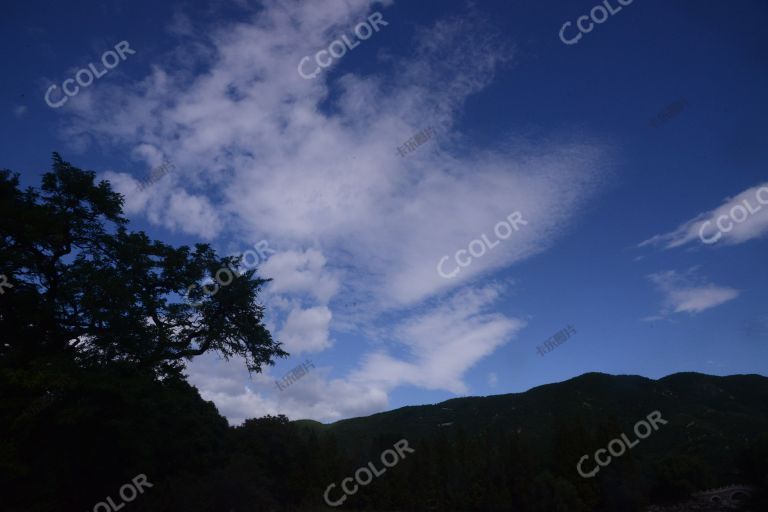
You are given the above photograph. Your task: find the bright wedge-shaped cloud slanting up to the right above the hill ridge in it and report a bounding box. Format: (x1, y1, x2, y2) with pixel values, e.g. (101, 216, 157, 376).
(349, 286, 525, 393)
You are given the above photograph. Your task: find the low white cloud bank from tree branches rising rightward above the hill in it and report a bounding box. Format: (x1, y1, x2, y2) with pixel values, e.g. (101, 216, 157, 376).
(188, 286, 525, 424)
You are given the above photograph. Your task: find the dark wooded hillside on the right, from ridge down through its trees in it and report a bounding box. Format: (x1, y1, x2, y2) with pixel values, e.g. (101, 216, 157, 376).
(296, 373, 768, 510)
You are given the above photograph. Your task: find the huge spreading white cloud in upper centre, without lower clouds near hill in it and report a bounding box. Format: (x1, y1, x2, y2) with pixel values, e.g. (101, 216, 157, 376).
(63, 1, 606, 308)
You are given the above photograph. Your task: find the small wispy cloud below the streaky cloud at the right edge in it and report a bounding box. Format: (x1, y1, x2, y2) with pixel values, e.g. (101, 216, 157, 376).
(648, 268, 739, 319)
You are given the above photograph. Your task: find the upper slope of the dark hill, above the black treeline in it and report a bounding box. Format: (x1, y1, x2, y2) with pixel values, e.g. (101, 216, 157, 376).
(316, 373, 768, 453)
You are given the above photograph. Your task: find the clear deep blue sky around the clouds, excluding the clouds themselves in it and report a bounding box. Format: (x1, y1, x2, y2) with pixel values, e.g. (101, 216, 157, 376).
(0, 0, 768, 422)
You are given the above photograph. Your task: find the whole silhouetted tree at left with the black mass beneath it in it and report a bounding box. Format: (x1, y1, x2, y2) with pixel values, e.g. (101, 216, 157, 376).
(0, 154, 286, 512)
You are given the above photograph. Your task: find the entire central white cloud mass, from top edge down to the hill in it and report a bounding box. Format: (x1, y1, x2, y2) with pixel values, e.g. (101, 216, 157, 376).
(57, 0, 610, 418)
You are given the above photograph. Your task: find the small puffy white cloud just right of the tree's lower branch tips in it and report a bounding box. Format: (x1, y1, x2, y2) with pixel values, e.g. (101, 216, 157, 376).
(278, 306, 331, 354)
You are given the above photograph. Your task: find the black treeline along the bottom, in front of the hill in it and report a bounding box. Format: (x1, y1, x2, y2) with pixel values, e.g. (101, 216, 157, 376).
(0, 361, 768, 512)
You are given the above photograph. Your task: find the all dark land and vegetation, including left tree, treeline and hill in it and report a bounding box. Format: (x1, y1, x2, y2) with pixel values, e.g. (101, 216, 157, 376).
(0, 155, 768, 512)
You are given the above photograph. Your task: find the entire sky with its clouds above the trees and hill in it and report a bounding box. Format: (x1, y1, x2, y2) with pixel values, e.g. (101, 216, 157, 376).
(0, 0, 768, 423)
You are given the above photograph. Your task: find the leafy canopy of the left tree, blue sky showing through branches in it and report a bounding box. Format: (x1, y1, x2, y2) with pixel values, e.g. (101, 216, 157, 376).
(0, 153, 288, 375)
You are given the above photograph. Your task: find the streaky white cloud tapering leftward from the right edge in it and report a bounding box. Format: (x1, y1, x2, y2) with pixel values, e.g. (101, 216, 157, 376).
(640, 182, 768, 249)
